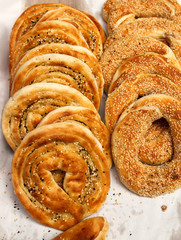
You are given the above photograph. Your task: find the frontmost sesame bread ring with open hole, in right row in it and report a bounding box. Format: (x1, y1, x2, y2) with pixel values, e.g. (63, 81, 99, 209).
(112, 94, 181, 197)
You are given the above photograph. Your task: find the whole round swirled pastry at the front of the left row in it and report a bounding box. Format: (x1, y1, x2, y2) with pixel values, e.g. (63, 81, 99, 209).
(12, 122, 110, 230)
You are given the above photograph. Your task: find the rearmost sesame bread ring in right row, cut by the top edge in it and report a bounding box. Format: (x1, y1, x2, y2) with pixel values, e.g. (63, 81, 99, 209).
(107, 0, 181, 34)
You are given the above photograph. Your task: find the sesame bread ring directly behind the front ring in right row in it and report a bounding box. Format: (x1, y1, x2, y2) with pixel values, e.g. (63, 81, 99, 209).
(105, 74, 181, 133)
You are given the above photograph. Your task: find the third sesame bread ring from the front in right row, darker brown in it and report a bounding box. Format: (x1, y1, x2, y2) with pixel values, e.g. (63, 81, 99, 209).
(109, 53, 181, 94)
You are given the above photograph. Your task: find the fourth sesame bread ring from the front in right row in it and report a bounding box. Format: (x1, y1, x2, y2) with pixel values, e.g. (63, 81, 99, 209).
(100, 36, 179, 92)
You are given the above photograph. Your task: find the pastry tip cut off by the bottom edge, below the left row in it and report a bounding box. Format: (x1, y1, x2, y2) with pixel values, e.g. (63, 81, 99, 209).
(53, 217, 109, 240)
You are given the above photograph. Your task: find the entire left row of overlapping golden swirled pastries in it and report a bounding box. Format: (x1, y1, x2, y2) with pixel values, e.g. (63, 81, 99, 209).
(2, 4, 112, 239)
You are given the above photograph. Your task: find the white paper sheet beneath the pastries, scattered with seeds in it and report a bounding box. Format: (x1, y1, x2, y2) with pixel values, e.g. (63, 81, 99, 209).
(0, 0, 181, 240)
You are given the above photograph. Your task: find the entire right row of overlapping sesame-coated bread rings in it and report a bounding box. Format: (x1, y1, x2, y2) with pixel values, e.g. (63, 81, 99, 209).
(100, 0, 181, 197)
